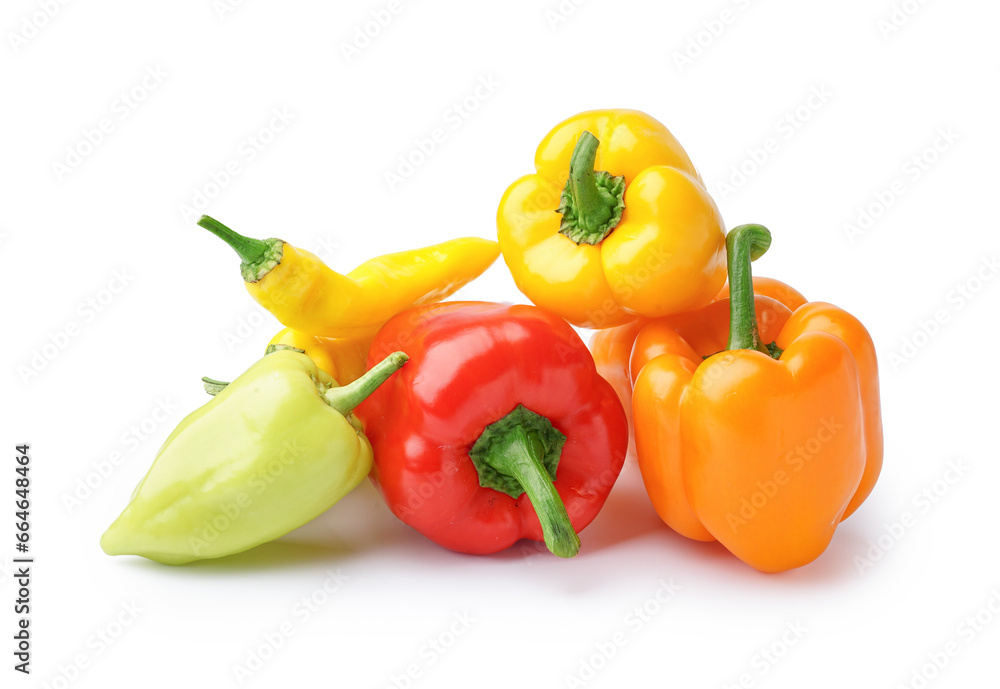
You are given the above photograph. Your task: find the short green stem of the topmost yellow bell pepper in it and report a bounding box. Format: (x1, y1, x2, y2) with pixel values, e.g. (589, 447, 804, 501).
(556, 132, 625, 245)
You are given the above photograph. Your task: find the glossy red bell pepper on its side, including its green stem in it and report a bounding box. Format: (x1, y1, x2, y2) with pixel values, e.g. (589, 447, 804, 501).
(358, 302, 628, 557)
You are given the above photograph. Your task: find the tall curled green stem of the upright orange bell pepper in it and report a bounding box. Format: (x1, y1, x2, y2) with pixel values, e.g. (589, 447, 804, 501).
(726, 224, 771, 356)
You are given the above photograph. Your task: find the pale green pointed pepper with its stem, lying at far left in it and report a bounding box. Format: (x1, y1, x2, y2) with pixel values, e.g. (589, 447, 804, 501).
(101, 349, 406, 565)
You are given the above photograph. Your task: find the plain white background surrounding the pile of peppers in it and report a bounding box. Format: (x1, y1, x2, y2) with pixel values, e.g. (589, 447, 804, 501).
(0, 0, 1000, 688)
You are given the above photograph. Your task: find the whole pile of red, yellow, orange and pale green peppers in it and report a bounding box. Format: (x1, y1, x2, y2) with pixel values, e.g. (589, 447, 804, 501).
(101, 110, 882, 572)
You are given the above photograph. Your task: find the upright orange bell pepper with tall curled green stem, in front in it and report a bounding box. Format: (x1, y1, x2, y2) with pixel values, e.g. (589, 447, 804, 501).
(632, 225, 882, 572)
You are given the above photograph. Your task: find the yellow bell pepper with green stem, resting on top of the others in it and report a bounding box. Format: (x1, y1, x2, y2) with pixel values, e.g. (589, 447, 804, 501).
(497, 110, 726, 328)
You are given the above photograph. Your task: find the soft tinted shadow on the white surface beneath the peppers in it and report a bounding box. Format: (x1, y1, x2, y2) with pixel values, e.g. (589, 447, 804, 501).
(103, 462, 869, 590)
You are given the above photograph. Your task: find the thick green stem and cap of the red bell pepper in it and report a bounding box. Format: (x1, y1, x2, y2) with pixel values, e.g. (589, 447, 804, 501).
(469, 405, 580, 557)
